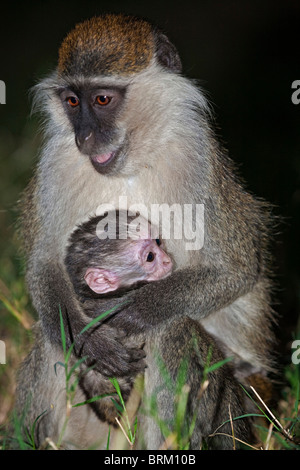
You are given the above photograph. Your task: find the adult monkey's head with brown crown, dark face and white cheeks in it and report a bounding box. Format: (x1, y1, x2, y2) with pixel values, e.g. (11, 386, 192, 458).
(36, 15, 181, 176)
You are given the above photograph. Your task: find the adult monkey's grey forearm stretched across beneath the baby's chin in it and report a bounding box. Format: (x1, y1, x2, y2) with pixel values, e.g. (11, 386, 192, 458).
(101, 267, 258, 333)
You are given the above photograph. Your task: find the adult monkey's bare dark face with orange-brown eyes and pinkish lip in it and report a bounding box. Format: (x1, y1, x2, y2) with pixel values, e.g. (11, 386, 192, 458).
(57, 83, 126, 174)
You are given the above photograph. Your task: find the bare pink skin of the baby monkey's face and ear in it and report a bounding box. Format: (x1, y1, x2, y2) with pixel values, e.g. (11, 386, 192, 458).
(84, 238, 173, 294)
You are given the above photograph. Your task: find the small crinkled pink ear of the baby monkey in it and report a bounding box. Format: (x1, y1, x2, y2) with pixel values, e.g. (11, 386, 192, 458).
(84, 267, 120, 294)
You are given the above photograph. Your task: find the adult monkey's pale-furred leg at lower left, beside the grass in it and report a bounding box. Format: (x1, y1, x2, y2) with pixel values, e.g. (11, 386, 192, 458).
(15, 324, 114, 449)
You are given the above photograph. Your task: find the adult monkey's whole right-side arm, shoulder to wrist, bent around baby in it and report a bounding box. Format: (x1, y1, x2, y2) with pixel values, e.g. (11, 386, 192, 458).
(102, 189, 267, 333)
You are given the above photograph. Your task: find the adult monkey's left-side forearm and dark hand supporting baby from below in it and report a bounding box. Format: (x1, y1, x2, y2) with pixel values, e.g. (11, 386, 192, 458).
(27, 260, 145, 377)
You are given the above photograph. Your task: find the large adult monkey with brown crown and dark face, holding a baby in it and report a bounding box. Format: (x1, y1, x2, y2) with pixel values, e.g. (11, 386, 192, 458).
(17, 15, 272, 448)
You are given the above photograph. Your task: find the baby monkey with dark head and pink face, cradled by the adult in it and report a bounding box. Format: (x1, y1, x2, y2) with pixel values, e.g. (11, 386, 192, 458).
(65, 210, 173, 424)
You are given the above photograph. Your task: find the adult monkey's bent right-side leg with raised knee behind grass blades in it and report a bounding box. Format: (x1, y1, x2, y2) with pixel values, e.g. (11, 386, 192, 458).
(141, 317, 252, 450)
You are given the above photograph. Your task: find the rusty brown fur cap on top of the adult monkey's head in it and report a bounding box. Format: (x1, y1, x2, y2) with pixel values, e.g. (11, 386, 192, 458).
(58, 15, 155, 75)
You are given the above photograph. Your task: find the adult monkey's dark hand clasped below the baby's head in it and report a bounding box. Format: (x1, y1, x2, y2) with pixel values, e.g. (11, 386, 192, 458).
(75, 324, 146, 378)
